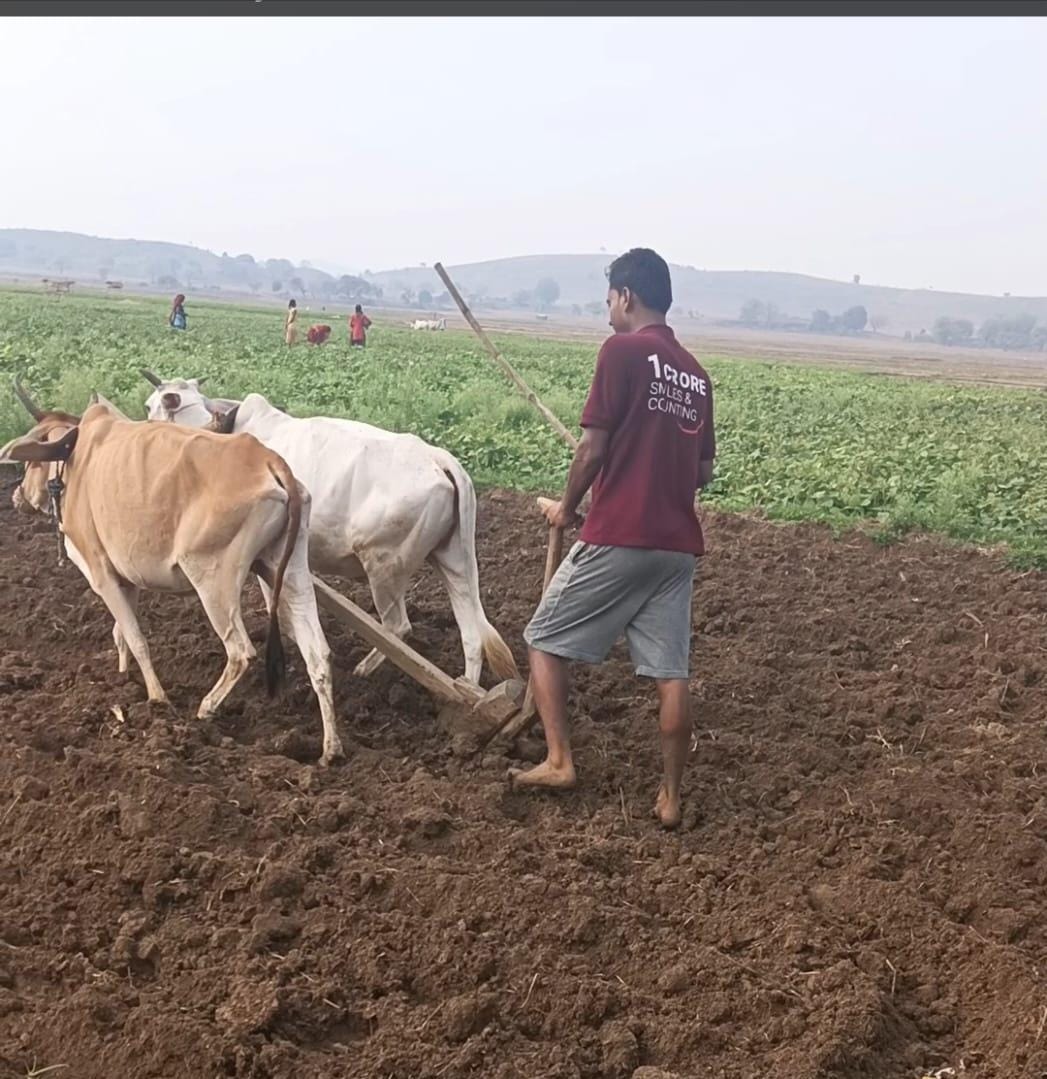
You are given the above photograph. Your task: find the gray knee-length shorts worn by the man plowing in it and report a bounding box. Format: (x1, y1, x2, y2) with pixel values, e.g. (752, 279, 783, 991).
(524, 543, 696, 679)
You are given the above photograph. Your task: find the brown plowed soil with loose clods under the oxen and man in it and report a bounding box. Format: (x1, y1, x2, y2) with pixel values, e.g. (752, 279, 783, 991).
(0, 483, 1047, 1079)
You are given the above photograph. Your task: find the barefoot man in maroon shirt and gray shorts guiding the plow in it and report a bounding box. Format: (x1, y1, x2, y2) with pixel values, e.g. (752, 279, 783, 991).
(511, 248, 716, 828)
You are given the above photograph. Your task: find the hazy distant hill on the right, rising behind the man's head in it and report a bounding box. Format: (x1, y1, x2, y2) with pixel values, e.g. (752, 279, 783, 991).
(369, 255, 1047, 334)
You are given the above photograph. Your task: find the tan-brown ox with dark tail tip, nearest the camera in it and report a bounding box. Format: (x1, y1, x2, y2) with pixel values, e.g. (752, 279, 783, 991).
(0, 387, 342, 764)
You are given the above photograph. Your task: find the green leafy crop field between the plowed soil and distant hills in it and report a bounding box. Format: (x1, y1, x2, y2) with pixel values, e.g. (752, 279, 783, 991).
(6, 290, 1047, 565)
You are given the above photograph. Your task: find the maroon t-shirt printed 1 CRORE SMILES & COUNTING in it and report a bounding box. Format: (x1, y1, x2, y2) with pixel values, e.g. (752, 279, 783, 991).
(581, 326, 716, 555)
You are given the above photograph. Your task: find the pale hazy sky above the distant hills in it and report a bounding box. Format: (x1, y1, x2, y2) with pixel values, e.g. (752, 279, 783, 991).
(0, 17, 1047, 295)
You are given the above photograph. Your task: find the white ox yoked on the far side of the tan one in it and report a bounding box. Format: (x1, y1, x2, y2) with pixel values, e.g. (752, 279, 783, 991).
(142, 372, 519, 683)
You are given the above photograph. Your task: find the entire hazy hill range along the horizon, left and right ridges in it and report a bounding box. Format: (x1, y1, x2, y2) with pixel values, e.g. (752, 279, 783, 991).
(0, 229, 1047, 336)
